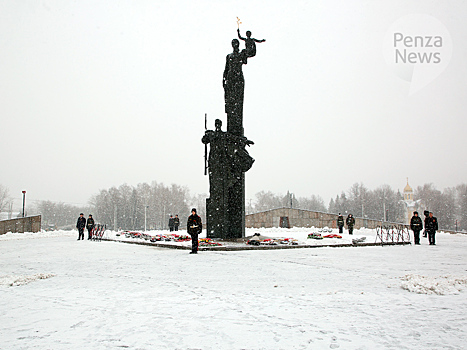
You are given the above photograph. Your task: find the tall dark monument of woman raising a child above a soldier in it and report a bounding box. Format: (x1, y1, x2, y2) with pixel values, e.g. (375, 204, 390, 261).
(202, 18, 265, 240)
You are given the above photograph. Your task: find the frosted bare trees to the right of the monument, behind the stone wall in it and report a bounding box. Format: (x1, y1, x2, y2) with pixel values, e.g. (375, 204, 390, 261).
(252, 183, 467, 231)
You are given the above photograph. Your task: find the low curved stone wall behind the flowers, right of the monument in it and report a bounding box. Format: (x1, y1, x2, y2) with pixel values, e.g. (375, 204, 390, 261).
(245, 208, 382, 229)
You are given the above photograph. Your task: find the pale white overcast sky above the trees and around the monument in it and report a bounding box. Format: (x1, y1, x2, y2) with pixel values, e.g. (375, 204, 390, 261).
(0, 0, 467, 208)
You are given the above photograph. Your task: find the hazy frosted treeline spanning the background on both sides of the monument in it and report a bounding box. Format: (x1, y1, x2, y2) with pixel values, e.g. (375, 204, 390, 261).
(4, 181, 467, 230)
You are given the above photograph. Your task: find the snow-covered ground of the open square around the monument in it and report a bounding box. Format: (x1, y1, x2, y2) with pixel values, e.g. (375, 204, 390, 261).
(0, 229, 467, 349)
